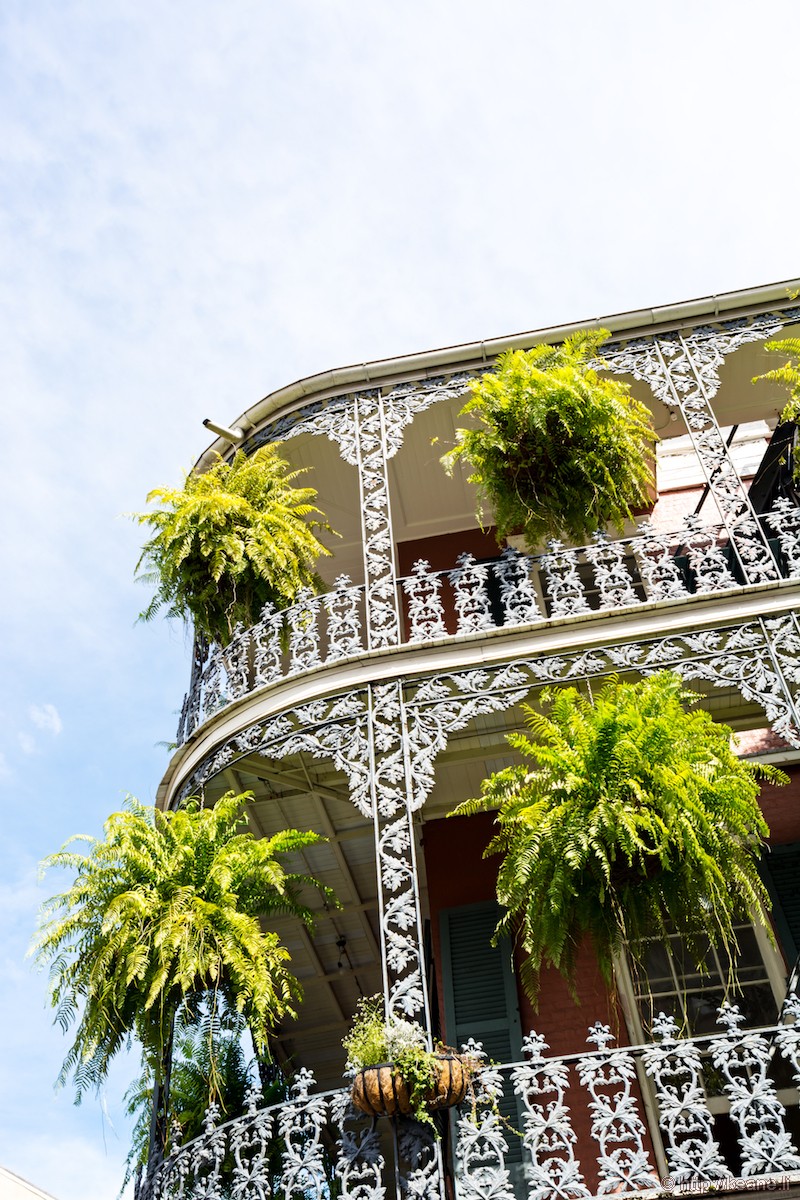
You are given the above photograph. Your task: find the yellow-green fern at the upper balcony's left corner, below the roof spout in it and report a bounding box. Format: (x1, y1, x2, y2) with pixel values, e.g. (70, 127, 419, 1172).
(133, 443, 332, 644)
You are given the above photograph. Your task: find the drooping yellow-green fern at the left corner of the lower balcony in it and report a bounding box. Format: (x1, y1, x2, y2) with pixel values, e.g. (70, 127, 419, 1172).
(31, 792, 338, 1148)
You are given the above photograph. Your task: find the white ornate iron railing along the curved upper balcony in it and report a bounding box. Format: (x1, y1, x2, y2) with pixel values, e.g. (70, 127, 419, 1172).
(176, 500, 800, 745)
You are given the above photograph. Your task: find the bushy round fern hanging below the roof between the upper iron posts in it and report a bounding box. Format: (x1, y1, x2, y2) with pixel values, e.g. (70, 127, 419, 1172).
(441, 329, 656, 548)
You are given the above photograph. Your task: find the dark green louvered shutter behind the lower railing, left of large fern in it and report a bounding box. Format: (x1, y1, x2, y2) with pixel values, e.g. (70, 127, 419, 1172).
(440, 902, 522, 1164)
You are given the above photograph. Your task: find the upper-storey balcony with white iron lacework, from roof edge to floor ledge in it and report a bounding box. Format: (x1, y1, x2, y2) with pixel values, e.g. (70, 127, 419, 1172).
(161, 286, 800, 803)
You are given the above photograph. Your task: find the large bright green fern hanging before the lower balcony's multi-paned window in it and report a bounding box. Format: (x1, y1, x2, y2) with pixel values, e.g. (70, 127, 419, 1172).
(453, 672, 787, 1003)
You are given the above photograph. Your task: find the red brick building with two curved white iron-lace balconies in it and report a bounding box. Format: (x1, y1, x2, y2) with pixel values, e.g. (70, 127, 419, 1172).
(140, 283, 800, 1200)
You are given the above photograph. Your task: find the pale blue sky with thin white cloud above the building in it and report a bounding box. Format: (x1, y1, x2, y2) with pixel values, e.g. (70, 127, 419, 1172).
(0, 0, 800, 1200)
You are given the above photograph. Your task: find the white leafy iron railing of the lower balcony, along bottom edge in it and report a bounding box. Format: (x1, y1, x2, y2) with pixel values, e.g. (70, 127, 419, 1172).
(136, 996, 800, 1200)
